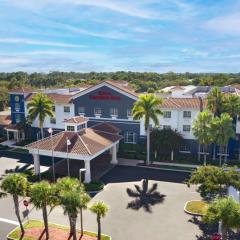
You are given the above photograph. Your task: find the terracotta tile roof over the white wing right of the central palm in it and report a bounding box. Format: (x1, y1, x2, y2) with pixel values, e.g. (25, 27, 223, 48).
(161, 98, 204, 109)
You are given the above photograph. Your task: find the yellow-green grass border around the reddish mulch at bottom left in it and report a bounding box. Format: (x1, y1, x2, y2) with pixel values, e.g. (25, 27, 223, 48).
(8, 220, 111, 240)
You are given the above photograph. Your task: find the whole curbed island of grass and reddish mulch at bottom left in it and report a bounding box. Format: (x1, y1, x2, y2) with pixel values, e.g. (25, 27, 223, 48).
(7, 220, 111, 240)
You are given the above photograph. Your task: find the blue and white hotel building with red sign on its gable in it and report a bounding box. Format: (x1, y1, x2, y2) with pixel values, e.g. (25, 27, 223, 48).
(7, 81, 240, 158)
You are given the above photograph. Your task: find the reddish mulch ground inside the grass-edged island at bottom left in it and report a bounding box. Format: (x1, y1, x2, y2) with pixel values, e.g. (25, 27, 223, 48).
(15, 226, 97, 240)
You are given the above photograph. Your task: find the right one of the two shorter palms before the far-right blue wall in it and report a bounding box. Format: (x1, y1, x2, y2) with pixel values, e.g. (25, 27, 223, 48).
(210, 113, 235, 166)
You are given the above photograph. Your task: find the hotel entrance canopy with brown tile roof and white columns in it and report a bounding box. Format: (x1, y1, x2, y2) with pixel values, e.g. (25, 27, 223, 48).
(26, 122, 122, 182)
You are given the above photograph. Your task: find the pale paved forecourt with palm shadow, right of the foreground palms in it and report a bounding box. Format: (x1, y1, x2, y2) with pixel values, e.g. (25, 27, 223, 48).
(80, 166, 208, 240)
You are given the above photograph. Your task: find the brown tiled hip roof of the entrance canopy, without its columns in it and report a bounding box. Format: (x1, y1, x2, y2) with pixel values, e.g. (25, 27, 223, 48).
(26, 128, 122, 156)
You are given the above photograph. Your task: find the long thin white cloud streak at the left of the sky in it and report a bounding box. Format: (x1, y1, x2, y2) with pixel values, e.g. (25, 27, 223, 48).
(0, 38, 84, 48)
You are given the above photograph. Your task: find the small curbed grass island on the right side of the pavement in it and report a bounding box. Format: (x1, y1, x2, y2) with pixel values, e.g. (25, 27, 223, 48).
(184, 200, 208, 216)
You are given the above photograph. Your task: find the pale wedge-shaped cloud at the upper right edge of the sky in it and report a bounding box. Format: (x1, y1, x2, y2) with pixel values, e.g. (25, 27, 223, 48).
(204, 13, 240, 35)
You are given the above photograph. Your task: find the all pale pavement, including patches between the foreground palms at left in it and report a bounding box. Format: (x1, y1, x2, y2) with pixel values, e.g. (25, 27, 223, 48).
(0, 165, 206, 240)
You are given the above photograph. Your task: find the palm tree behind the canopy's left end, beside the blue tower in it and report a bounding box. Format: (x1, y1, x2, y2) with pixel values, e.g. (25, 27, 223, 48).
(27, 93, 54, 138)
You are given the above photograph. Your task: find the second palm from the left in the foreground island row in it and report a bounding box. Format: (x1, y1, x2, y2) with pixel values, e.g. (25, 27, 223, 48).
(30, 181, 53, 239)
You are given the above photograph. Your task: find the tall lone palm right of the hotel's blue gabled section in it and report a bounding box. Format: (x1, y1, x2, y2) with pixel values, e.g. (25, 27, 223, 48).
(132, 94, 162, 165)
